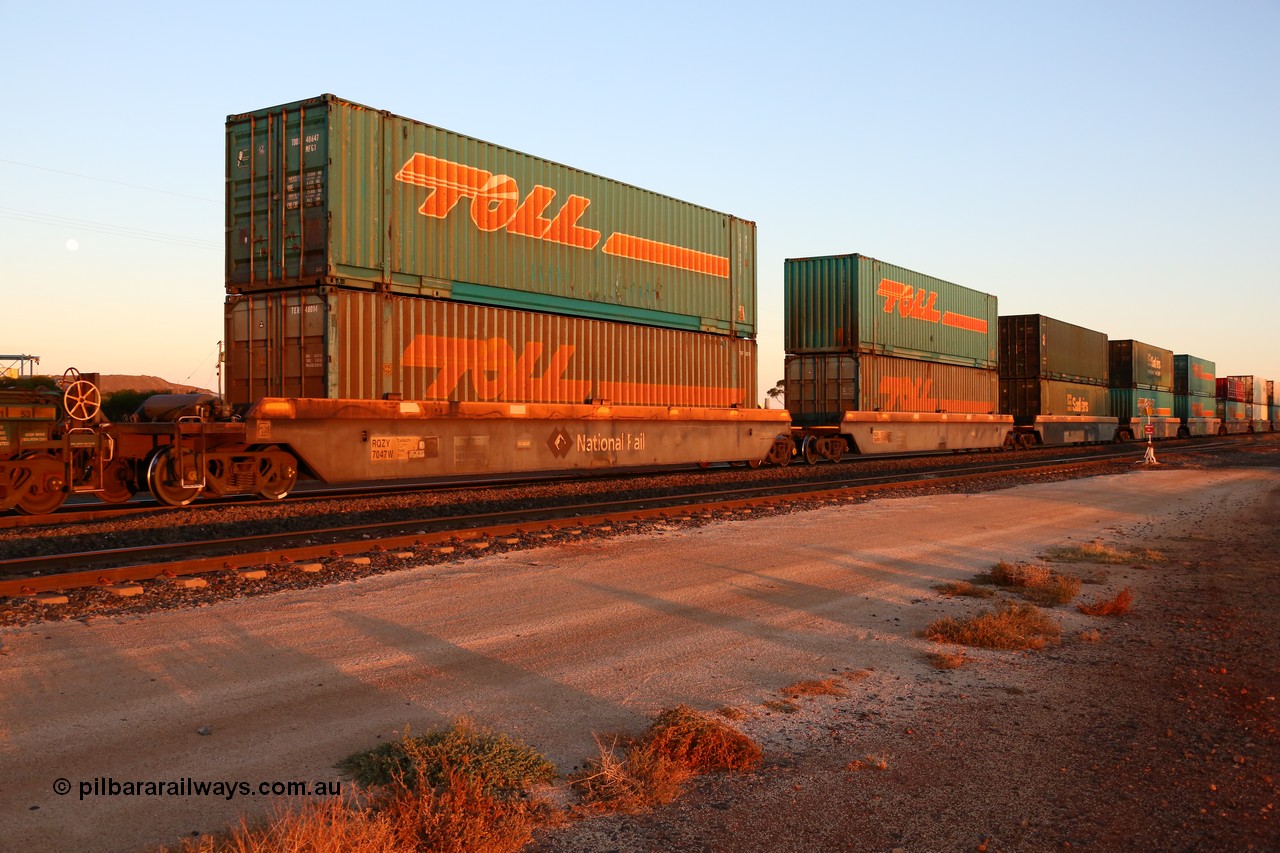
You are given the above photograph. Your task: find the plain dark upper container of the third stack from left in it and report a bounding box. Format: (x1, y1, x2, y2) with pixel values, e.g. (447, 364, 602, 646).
(1000, 314, 1110, 386)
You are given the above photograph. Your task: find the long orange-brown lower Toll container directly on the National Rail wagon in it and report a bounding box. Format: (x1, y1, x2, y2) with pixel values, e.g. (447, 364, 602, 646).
(225, 288, 756, 407)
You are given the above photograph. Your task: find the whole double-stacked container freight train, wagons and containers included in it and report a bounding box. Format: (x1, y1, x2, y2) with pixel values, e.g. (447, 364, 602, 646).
(0, 95, 1276, 514)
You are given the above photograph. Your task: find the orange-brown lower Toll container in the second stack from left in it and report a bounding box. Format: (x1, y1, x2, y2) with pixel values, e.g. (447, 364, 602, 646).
(785, 353, 998, 427)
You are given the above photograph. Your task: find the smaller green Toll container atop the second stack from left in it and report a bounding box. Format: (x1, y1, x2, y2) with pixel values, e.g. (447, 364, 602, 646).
(783, 255, 1000, 369)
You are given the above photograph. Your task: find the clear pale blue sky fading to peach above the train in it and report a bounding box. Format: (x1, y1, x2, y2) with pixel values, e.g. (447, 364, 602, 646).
(0, 0, 1280, 389)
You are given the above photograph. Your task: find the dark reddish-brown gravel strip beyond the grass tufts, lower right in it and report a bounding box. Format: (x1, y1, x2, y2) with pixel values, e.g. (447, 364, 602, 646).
(531, 440, 1280, 853)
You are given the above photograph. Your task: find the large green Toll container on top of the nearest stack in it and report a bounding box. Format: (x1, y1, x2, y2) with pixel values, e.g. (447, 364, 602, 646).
(227, 95, 755, 337)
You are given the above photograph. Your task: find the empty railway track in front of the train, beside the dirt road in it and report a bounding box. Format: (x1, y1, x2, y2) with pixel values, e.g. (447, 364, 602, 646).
(0, 442, 1229, 598)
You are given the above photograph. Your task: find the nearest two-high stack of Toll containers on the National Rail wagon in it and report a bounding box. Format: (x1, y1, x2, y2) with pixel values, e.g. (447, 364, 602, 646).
(227, 95, 756, 406)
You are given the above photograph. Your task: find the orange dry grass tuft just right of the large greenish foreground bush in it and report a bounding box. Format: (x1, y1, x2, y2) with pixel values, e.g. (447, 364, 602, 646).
(571, 704, 760, 812)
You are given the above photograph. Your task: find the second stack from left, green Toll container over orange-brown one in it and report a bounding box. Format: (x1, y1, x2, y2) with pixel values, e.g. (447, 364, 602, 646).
(783, 255, 998, 427)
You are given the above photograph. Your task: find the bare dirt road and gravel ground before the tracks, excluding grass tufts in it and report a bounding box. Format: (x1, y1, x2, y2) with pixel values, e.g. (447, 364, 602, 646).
(0, 456, 1280, 852)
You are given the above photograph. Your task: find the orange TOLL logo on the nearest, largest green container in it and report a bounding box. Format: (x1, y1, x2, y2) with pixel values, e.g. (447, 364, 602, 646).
(396, 154, 730, 278)
